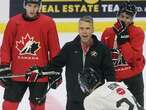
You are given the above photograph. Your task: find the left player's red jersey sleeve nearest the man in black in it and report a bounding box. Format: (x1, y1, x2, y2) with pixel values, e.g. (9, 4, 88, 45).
(48, 19, 60, 59)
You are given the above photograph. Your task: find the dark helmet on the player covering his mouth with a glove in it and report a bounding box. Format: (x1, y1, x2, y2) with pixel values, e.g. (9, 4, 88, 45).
(117, 2, 137, 17)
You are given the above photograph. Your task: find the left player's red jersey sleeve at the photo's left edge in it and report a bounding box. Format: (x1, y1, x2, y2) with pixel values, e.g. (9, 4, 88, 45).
(0, 20, 16, 64)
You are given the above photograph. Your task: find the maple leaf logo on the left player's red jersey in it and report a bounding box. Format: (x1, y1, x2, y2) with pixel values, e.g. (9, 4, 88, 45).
(16, 33, 40, 55)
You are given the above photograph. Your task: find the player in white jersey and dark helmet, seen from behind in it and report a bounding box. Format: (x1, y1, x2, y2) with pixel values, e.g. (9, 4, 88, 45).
(78, 68, 144, 110)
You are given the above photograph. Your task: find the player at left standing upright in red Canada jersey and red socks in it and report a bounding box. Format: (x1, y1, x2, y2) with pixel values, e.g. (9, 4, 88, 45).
(0, 0, 60, 110)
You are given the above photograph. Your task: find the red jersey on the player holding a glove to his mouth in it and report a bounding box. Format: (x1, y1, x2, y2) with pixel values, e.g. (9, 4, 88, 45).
(101, 25, 145, 81)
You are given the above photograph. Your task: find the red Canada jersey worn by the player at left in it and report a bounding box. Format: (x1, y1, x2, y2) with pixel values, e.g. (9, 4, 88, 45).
(1, 14, 60, 82)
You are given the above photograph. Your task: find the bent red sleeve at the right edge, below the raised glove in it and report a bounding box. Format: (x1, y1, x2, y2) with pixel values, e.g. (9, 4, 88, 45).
(120, 28, 144, 66)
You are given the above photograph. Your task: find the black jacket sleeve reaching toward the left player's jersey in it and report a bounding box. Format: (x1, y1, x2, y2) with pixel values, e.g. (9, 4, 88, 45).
(43, 44, 68, 71)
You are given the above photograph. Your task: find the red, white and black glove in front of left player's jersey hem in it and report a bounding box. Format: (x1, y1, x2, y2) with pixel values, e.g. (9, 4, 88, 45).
(25, 66, 43, 82)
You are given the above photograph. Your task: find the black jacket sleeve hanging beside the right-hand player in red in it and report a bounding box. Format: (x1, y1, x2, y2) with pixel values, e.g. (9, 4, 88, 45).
(101, 46, 115, 81)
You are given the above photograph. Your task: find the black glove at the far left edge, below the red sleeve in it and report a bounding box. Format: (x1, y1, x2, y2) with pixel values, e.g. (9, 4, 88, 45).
(0, 65, 12, 88)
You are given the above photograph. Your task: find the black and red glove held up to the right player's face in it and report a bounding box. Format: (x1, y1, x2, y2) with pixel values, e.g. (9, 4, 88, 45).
(113, 20, 130, 45)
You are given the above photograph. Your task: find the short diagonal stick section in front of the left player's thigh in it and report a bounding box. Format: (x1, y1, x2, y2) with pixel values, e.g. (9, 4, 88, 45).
(35, 76, 62, 104)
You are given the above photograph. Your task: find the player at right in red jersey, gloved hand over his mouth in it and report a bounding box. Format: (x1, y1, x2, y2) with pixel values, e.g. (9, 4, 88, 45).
(101, 2, 145, 106)
